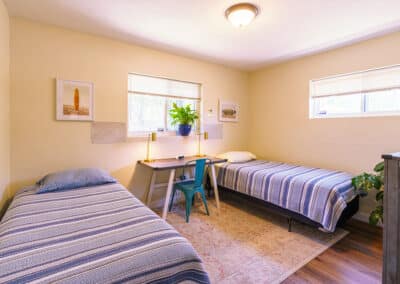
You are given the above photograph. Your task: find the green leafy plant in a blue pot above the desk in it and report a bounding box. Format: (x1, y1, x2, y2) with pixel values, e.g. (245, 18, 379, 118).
(169, 103, 199, 136)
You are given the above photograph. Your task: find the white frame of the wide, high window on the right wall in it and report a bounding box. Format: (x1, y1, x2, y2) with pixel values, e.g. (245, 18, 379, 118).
(309, 64, 400, 119)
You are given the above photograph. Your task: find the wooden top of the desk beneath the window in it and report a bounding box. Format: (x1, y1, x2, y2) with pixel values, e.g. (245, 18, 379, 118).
(138, 156, 227, 170)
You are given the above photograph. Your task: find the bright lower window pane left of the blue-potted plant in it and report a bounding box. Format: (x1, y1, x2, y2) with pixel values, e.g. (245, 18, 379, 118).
(128, 94, 166, 132)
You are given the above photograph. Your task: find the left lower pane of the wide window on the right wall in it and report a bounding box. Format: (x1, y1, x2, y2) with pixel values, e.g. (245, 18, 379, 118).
(314, 94, 362, 116)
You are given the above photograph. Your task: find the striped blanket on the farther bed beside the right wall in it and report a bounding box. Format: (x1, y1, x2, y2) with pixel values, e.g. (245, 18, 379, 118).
(218, 160, 355, 232)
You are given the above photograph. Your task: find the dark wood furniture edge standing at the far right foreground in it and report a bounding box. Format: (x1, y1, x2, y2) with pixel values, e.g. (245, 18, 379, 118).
(382, 153, 400, 284)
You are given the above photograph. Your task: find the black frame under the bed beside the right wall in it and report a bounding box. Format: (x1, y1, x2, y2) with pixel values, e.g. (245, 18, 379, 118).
(208, 180, 360, 232)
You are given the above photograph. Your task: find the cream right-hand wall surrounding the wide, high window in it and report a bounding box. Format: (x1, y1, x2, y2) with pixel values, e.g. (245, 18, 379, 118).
(249, 32, 400, 218)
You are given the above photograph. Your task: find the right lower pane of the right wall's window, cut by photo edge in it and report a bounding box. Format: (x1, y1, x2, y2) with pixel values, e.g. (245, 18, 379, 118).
(366, 90, 400, 112)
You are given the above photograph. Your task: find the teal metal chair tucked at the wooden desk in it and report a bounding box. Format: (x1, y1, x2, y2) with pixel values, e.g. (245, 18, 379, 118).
(169, 159, 210, 223)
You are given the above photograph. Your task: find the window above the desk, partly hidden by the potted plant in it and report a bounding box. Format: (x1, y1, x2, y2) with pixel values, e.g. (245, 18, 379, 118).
(128, 74, 200, 136)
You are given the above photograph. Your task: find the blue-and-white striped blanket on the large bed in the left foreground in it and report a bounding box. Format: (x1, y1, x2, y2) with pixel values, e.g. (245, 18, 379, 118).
(0, 184, 209, 283)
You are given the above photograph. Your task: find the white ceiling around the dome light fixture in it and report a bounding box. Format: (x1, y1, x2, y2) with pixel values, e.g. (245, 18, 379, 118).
(5, 0, 400, 70)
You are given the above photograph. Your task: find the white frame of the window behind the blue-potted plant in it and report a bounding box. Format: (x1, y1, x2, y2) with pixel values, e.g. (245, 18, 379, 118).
(126, 72, 203, 138)
